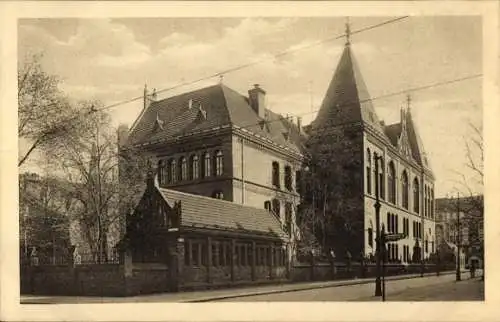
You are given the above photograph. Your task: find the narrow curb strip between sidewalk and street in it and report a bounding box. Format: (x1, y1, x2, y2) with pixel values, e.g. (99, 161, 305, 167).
(184, 271, 455, 303)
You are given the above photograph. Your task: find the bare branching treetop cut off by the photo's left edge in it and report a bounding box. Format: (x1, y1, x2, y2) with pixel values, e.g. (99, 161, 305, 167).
(17, 54, 80, 166)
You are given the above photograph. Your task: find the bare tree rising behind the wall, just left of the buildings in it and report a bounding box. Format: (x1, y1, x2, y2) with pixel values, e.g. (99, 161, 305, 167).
(46, 102, 145, 262)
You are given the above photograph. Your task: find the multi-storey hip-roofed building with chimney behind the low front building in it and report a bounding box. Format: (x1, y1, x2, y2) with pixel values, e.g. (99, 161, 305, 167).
(126, 84, 306, 260)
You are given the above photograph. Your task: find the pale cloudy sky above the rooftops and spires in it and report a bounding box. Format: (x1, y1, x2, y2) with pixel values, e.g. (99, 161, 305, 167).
(18, 16, 483, 197)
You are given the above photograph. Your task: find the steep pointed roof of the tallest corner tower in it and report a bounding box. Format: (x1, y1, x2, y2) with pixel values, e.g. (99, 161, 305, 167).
(312, 44, 384, 134)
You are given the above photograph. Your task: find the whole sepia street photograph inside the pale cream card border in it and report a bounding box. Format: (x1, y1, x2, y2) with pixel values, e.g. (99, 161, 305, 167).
(2, 0, 491, 320)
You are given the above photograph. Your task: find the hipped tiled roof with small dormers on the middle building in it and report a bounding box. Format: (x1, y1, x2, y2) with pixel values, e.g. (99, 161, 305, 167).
(128, 84, 305, 152)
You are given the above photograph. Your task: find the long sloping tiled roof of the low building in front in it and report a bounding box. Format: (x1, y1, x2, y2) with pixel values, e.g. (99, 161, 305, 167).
(157, 188, 287, 239)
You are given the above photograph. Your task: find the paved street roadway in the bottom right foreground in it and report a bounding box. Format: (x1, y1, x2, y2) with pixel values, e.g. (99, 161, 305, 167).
(214, 274, 484, 302)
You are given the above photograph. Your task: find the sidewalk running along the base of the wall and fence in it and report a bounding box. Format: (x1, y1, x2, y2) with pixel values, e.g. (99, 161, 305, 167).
(21, 271, 466, 304)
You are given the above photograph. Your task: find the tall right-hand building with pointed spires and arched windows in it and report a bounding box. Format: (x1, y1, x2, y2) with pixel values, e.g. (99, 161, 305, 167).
(308, 25, 436, 262)
